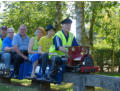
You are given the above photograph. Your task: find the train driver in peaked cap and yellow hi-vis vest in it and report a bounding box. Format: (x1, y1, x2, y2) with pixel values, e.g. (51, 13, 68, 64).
(49, 18, 78, 80)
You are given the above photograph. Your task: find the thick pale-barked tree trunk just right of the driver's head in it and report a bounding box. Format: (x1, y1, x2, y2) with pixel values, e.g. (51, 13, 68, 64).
(75, 1, 88, 46)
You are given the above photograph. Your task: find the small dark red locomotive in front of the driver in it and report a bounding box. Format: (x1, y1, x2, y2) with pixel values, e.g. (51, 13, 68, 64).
(67, 46, 99, 73)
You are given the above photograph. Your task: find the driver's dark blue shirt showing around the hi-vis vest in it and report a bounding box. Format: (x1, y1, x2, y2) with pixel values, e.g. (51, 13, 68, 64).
(53, 30, 78, 50)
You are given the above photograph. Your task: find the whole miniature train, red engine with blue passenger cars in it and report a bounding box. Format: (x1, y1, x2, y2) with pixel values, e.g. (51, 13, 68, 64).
(0, 46, 99, 84)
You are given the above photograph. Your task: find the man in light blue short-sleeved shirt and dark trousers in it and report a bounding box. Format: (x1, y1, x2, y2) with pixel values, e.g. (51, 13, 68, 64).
(12, 25, 29, 75)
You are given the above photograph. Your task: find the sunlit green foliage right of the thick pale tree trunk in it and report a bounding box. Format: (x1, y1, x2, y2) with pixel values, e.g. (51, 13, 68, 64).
(86, 1, 120, 71)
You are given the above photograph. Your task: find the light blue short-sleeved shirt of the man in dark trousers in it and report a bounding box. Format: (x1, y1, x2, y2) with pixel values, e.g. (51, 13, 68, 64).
(12, 33, 29, 50)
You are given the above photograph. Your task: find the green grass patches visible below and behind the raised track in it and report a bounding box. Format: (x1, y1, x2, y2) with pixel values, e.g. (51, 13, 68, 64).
(0, 73, 120, 91)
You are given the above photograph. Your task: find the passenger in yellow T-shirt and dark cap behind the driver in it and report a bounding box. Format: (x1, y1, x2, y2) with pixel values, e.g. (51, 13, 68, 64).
(38, 25, 55, 77)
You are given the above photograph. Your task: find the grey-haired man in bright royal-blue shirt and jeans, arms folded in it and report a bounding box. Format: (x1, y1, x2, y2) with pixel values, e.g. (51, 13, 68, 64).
(1, 28, 14, 68)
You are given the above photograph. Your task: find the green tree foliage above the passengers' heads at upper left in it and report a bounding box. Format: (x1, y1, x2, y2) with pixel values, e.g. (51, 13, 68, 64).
(2, 1, 66, 35)
